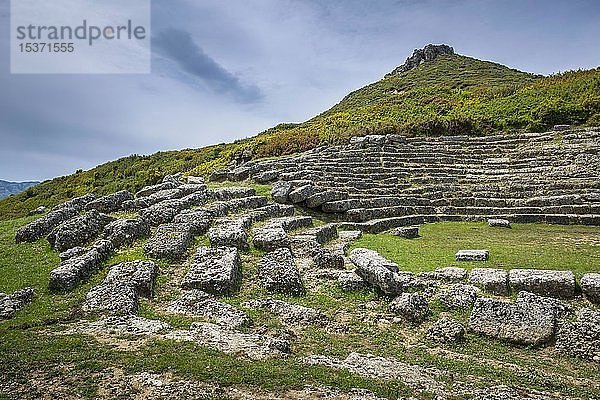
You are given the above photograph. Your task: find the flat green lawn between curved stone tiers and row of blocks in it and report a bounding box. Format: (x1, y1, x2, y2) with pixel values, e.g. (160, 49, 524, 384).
(352, 222, 600, 277)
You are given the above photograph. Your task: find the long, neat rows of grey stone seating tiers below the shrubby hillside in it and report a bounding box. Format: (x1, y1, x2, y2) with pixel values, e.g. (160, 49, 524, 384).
(211, 128, 600, 233)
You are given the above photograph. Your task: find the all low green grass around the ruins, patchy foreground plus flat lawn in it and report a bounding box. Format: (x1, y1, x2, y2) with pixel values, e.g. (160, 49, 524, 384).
(0, 218, 600, 399)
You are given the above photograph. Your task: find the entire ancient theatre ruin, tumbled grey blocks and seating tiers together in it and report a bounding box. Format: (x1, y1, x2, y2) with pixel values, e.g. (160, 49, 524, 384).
(9, 129, 600, 398)
